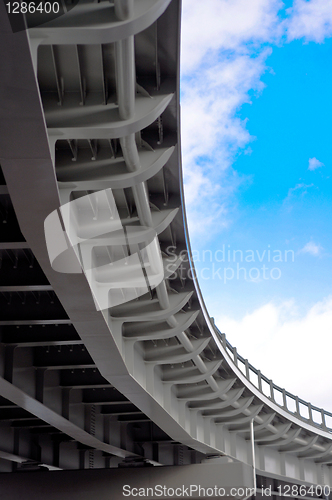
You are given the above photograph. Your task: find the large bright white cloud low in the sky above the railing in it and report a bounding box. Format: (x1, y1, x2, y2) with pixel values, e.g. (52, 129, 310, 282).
(215, 297, 332, 411)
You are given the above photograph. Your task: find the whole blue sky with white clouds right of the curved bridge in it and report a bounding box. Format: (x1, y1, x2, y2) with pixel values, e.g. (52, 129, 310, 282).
(181, 0, 332, 414)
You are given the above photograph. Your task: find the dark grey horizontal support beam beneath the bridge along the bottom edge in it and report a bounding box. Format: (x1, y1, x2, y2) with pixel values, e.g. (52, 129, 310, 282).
(1, 463, 253, 500)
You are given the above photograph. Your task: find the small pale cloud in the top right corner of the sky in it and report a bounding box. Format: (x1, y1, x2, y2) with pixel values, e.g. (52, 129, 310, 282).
(286, 0, 332, 43)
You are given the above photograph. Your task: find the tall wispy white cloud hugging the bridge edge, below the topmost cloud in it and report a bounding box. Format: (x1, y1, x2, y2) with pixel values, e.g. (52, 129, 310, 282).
(181, 49, 269, 236)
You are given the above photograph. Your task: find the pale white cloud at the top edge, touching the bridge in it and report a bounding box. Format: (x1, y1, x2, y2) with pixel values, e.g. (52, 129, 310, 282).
(181, 0, 282, 74)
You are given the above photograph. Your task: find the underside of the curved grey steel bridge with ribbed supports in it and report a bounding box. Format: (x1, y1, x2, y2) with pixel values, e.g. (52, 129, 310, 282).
(0, 0, 332, 498)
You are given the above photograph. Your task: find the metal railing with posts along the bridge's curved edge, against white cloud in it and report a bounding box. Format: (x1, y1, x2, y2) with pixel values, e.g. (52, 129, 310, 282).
(215, 326, 332, 432)
